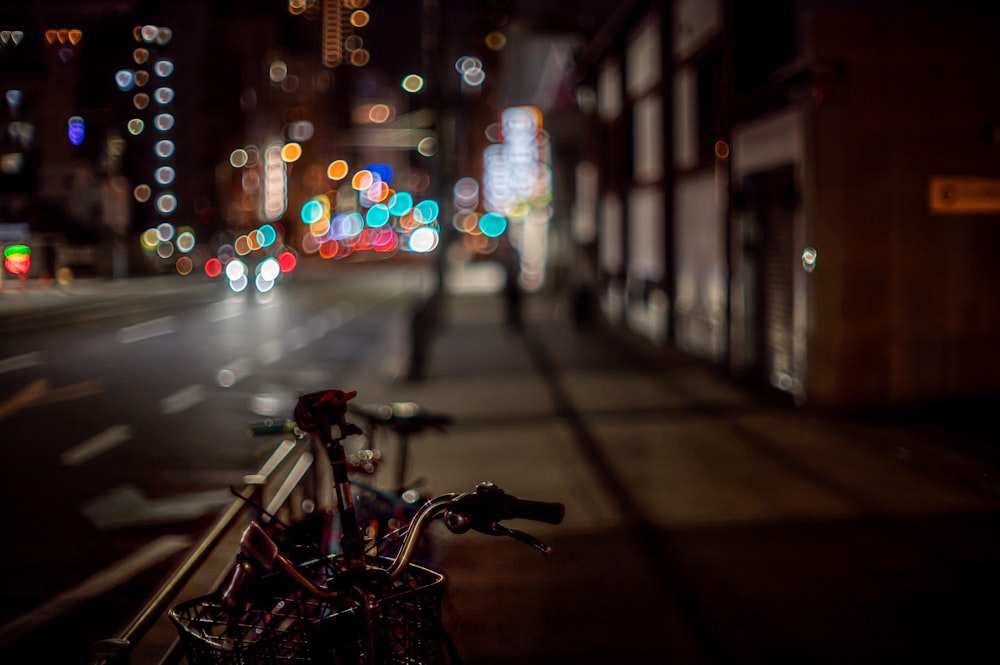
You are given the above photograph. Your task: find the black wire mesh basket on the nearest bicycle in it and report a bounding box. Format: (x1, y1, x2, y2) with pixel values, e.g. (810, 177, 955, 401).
(169, 558, 444, 665)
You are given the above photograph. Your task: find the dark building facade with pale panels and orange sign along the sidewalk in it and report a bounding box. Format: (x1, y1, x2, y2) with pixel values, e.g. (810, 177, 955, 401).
(576, 0, 1000, 408)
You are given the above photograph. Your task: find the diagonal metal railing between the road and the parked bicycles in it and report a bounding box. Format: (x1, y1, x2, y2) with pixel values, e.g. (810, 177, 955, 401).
(91, 440, 328, 665)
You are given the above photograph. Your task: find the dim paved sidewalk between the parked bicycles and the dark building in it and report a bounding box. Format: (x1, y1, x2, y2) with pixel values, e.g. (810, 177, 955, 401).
(338, 282, 1000, 664)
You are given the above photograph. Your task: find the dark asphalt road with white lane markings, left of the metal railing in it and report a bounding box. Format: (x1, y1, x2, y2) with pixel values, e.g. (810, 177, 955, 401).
(0, 267, 420, 663)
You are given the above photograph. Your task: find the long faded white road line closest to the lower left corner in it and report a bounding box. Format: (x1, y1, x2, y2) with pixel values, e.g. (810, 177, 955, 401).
(0, 535, 191, 647)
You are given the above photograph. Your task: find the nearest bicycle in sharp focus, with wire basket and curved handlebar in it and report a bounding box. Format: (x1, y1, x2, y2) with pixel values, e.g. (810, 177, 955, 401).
(169, 390, 565, 665)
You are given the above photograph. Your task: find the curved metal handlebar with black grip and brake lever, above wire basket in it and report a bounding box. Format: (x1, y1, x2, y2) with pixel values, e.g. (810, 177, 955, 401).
(222, 482, 566, 604)
